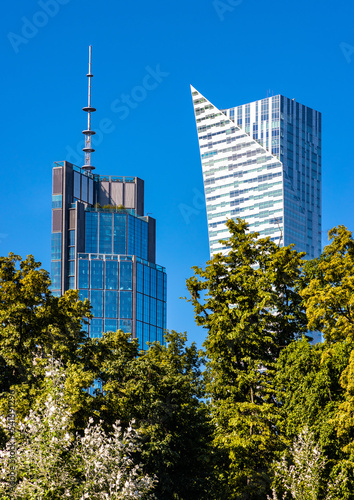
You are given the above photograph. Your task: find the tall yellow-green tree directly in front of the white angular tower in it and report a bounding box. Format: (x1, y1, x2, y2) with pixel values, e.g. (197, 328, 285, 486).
(187, 219, 306, 499)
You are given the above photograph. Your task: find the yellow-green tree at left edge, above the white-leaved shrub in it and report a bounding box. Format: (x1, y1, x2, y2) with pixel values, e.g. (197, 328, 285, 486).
(0, 253, 91, 422)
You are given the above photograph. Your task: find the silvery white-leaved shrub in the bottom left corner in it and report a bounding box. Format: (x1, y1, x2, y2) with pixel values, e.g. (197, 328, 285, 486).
(0, 363, 155, 500)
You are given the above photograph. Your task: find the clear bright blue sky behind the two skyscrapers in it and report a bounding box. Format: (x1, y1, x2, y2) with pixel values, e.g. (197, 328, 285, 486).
(0, 0, 354, 345)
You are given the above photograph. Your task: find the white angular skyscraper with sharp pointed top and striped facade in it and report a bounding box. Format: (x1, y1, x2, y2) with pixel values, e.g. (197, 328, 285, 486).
(192, 87, 321, 258)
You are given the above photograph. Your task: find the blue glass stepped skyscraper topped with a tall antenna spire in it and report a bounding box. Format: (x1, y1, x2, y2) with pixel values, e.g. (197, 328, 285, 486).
(51, 50, 166, 348)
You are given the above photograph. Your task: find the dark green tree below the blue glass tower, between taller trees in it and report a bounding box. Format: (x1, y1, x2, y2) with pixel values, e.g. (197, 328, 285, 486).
(87, 331, 213, 500)
